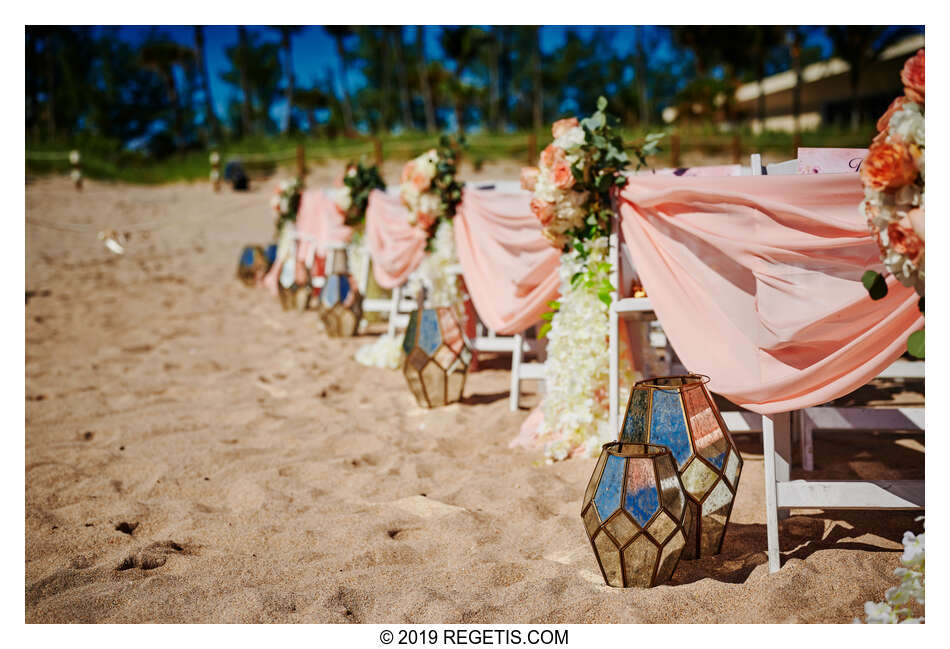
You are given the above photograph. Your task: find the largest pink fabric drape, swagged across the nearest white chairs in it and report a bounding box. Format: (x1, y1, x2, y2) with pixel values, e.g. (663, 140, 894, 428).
(618, 173, 923, 414)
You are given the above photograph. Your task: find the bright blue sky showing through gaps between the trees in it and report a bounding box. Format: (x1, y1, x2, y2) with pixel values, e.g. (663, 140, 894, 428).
(96, 25, 826, 125)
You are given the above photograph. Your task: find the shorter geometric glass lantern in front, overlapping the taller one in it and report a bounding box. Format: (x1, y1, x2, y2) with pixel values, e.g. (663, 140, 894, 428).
(581, 442, 692, 588)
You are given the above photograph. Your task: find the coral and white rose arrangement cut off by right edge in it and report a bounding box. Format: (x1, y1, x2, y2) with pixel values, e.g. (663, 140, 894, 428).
(861, 50, 925, 358)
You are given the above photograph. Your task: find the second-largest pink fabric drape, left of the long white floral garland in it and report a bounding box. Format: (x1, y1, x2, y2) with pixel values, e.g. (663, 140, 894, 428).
(455, 187, 560, 334)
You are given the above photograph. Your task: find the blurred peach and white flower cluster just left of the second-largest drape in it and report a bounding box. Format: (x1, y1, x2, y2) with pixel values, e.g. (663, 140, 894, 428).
(399, 136, 462, 244)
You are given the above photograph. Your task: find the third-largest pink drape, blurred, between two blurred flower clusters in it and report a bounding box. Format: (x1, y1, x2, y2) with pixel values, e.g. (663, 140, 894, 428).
(366, 189, 426, 289)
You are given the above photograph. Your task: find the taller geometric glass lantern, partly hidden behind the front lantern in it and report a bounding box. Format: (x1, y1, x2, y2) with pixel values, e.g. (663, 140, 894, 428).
(620, 374, 742, 559)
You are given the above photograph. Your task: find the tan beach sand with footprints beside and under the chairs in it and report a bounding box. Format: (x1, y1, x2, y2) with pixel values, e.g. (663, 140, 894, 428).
(25, 164, 923, 623)
